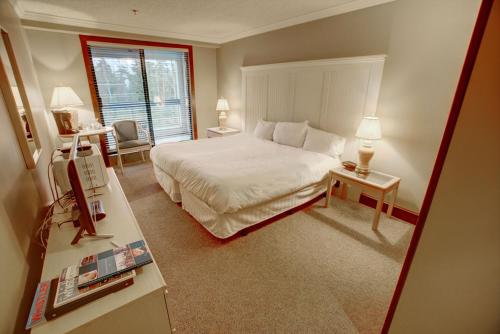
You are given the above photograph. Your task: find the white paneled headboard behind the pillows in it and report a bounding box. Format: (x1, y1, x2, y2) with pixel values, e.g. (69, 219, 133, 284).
(241, 55, 385, 159)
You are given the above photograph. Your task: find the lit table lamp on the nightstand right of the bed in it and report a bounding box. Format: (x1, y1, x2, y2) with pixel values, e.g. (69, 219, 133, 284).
(356, 116, 382, 174)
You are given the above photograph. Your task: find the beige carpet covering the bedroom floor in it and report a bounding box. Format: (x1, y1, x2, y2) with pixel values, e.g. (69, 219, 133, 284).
(117, 163, 413, 333)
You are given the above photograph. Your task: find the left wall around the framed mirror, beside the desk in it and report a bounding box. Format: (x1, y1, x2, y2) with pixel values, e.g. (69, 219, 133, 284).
(0, 1, 53, 333)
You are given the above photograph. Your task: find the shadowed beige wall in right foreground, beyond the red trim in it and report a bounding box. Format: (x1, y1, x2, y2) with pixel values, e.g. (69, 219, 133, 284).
(390, 1, 500, 334)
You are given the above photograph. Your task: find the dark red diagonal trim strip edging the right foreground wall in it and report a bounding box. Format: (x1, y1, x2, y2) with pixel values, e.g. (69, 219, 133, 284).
(382, 0, 494, 334)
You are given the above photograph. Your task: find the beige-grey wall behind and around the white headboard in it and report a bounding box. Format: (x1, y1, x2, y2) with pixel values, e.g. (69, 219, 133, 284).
(217, 0, 480, 211)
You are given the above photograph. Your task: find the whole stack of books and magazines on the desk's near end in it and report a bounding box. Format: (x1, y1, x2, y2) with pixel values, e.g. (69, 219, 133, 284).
(26, 240, 153, 329)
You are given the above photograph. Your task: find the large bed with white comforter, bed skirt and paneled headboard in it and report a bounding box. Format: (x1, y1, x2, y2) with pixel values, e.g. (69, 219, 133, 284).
(151, 55, 385, 238)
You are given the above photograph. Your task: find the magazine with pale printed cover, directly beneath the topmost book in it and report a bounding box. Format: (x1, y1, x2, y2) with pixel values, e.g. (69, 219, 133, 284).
(54, 266, 136, 308)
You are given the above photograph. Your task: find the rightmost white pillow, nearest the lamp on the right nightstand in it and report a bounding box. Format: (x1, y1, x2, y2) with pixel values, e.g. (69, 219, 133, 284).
(304, 128, 345, 159)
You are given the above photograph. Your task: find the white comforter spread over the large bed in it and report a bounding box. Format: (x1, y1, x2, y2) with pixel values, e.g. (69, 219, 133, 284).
(151, 134, 340, 214)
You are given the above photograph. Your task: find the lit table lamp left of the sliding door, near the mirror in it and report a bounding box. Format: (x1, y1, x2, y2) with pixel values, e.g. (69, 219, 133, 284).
(50, 86, 83, 135)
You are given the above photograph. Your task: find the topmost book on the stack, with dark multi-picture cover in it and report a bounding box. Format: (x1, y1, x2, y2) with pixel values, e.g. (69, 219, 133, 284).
(74, 240, 153, 288)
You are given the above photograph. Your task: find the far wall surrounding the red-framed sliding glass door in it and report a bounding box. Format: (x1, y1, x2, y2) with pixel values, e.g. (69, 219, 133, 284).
(26, 29, 217, 137)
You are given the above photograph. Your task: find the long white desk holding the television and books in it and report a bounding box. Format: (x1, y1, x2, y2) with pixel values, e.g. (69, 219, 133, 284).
(31, 168, 171, 334)
